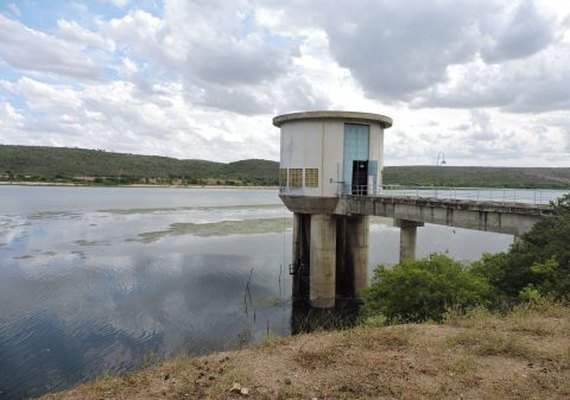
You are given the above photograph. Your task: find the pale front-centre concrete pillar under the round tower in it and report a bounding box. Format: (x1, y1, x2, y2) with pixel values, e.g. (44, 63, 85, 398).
(309, 215, 336, 308)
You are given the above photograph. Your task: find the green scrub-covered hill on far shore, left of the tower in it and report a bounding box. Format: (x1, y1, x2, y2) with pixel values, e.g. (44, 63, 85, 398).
(0, 145, 279, 185)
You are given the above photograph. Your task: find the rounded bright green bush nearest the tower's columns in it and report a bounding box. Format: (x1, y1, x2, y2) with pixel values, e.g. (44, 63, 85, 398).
(362, 254, 491, 323)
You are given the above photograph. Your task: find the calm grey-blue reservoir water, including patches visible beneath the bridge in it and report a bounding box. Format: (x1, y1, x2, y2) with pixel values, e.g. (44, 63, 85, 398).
(0, 185, 562, 399)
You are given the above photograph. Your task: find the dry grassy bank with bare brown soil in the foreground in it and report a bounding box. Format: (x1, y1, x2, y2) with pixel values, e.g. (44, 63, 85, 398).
(44, 304, 570, 399)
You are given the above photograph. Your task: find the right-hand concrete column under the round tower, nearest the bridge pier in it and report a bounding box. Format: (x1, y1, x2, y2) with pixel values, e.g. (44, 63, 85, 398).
(346, 217, 369, 300)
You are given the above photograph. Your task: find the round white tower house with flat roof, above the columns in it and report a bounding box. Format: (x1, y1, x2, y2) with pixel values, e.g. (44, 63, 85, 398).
(273, 111, 392, 197)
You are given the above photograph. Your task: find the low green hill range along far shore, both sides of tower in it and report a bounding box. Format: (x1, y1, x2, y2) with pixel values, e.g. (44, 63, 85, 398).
(0, 145, 570, 189)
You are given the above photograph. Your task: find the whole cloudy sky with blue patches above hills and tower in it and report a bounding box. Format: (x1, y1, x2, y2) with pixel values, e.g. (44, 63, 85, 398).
(0, 0, 570, 167)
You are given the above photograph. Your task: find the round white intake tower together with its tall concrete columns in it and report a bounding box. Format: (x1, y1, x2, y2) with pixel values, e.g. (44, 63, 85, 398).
(273, 111, 392, 308)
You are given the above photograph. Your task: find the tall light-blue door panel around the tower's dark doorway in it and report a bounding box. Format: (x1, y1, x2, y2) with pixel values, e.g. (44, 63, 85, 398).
(342, 124, 370, 194)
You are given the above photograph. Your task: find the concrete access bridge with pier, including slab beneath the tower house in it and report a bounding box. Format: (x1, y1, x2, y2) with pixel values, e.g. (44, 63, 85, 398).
(281, 194, 552, 261)
